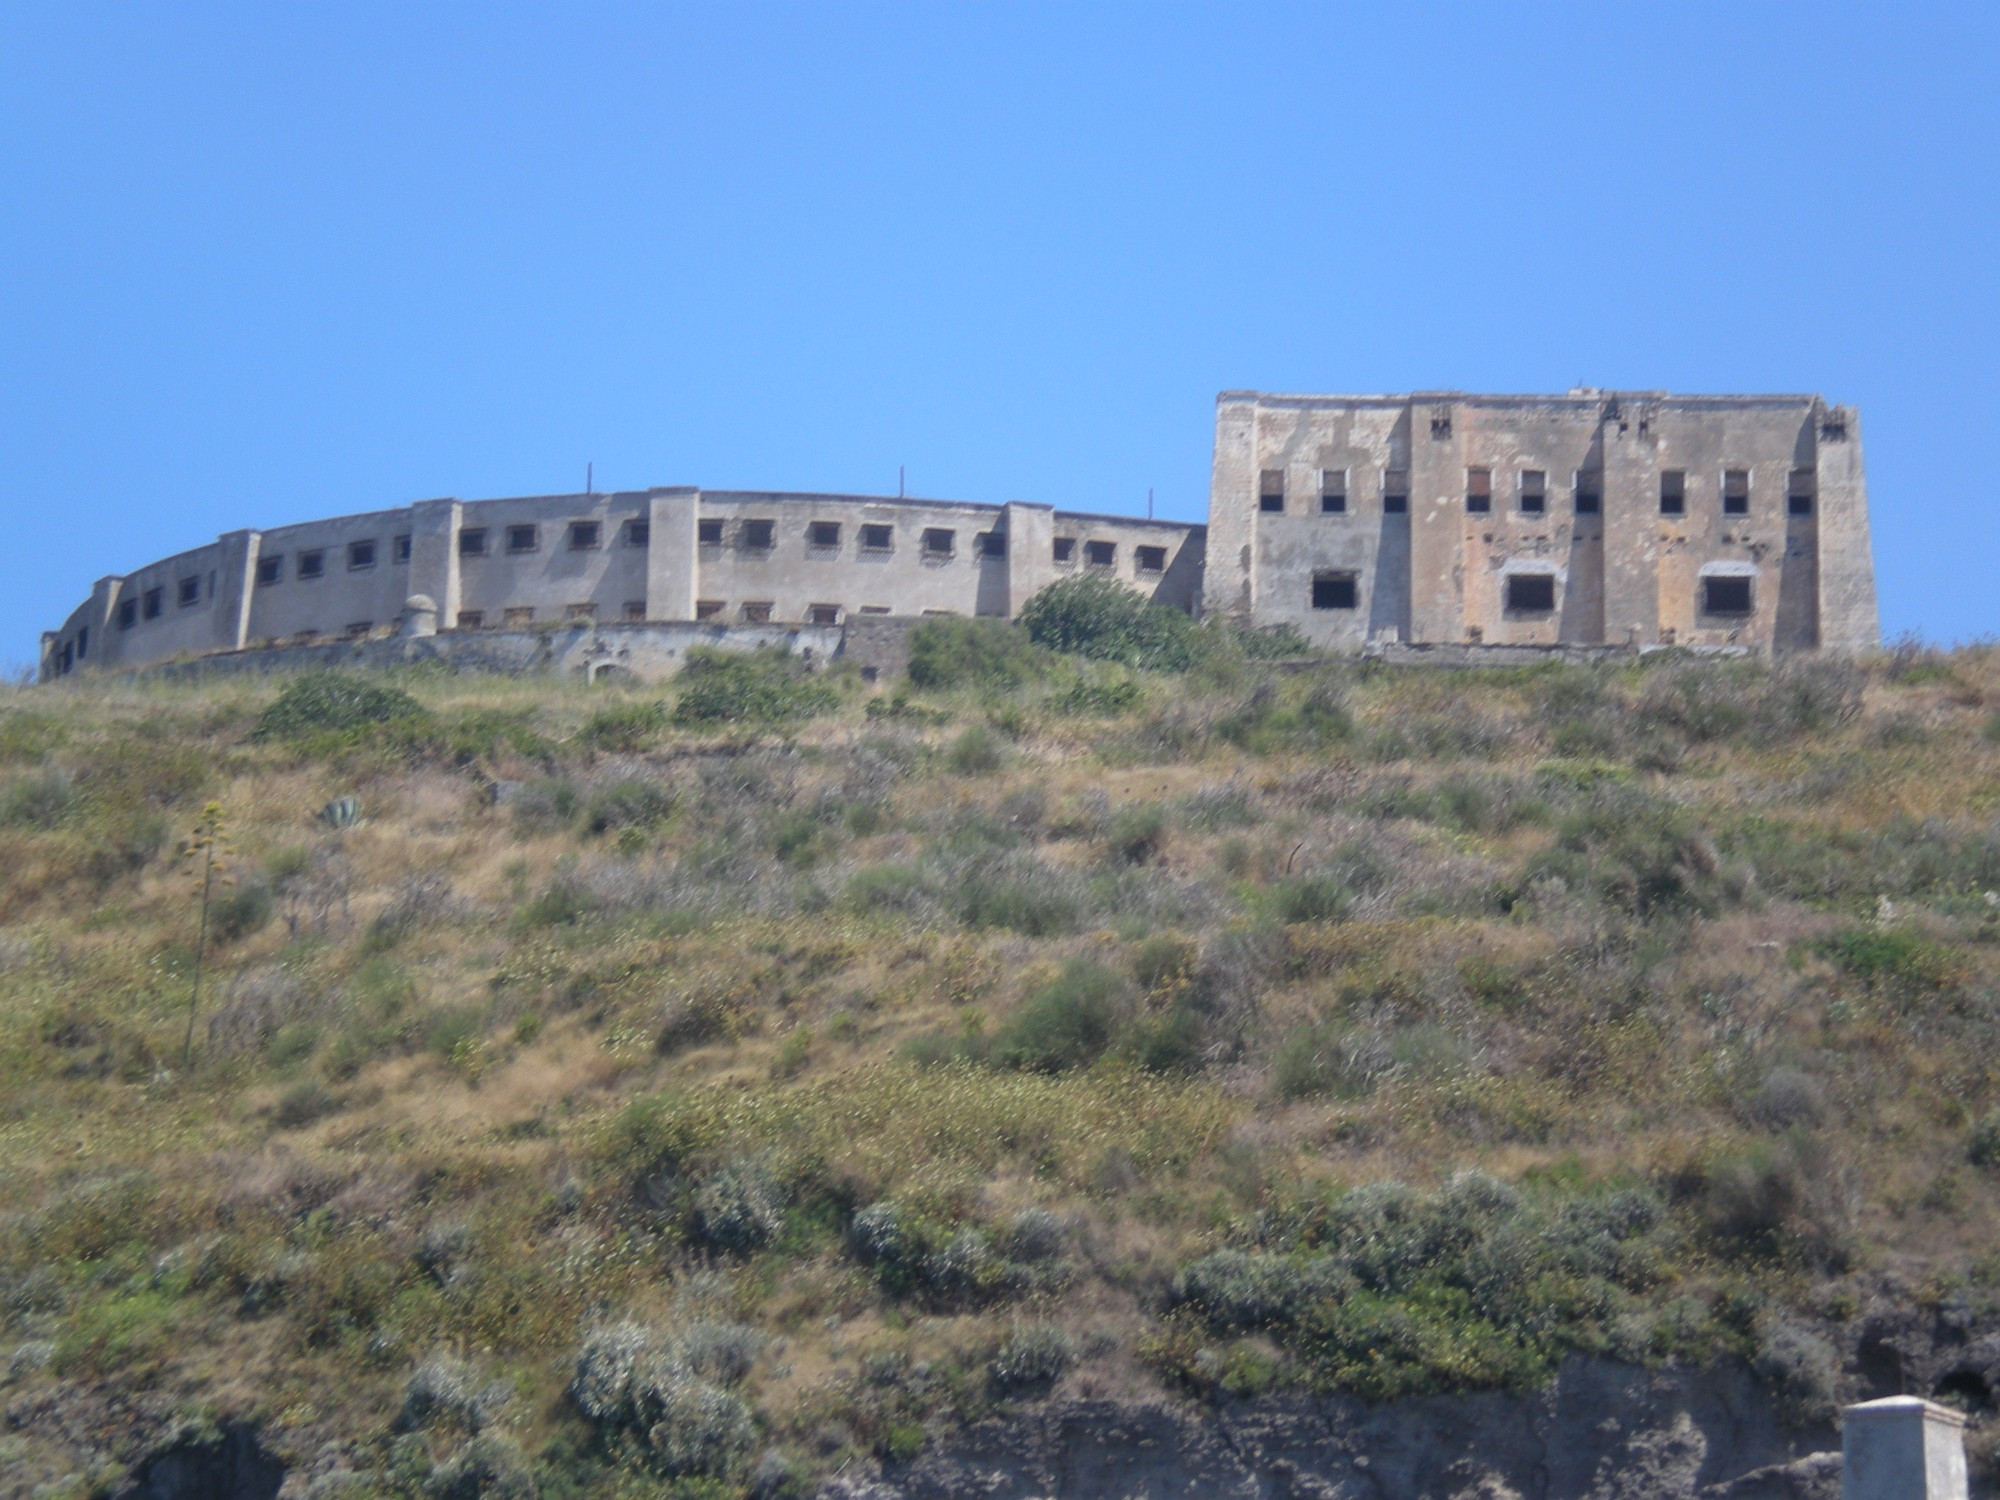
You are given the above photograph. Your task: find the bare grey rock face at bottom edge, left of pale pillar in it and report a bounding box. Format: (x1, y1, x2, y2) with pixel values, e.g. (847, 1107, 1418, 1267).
(822, 1358, 1840, 1500)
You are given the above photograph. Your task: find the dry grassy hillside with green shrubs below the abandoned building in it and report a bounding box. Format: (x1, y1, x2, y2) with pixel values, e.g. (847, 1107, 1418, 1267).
(0, 626, 2000, 1496)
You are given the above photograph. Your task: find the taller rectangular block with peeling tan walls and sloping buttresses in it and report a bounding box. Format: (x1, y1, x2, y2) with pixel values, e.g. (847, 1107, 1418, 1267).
(1204, 390, 1880, 652)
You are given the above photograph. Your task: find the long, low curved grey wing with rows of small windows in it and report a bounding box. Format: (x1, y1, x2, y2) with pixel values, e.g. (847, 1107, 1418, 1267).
(42, 488, 1204, 680)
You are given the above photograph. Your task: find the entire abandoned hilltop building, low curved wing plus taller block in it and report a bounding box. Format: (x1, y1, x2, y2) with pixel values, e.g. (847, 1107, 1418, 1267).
(42, 390, 1878, 678)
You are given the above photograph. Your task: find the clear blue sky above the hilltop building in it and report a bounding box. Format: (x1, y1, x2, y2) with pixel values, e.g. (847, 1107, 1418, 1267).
(0, 0, 2000, 662)
